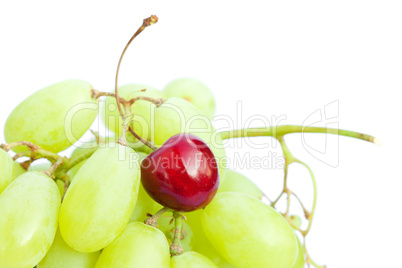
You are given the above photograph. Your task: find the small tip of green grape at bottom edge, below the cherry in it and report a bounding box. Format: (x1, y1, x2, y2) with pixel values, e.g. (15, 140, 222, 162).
(170, 251, 218, 268)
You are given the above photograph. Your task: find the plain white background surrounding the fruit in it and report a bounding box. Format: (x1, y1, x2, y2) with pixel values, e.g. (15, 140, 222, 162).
(0, 0, 402, 267)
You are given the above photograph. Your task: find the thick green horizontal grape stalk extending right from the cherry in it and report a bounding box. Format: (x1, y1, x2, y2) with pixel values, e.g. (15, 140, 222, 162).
(220, 125, 381, 145)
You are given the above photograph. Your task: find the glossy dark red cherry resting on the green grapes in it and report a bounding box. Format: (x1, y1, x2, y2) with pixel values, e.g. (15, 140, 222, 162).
(141, 133, 219, 212)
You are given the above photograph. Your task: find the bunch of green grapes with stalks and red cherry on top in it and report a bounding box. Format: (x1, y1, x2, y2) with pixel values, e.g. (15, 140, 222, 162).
(0, 16, 376, 268)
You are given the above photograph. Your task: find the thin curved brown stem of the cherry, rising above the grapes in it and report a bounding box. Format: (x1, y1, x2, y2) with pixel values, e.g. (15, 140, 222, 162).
(114, 15, 158, 150)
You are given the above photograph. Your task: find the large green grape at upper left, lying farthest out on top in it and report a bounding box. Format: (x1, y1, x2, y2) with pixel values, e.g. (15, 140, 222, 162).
(4, 80, 98, 153)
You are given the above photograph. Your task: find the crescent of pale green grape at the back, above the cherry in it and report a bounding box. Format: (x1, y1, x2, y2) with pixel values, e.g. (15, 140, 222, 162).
(163, 78, 216, 120)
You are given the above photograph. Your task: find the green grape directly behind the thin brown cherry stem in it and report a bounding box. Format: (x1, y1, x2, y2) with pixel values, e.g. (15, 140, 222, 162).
(101, 84, 164, 147)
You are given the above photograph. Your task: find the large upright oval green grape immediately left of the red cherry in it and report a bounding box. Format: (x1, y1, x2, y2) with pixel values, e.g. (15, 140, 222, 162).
(59, 144, 140, 252)
